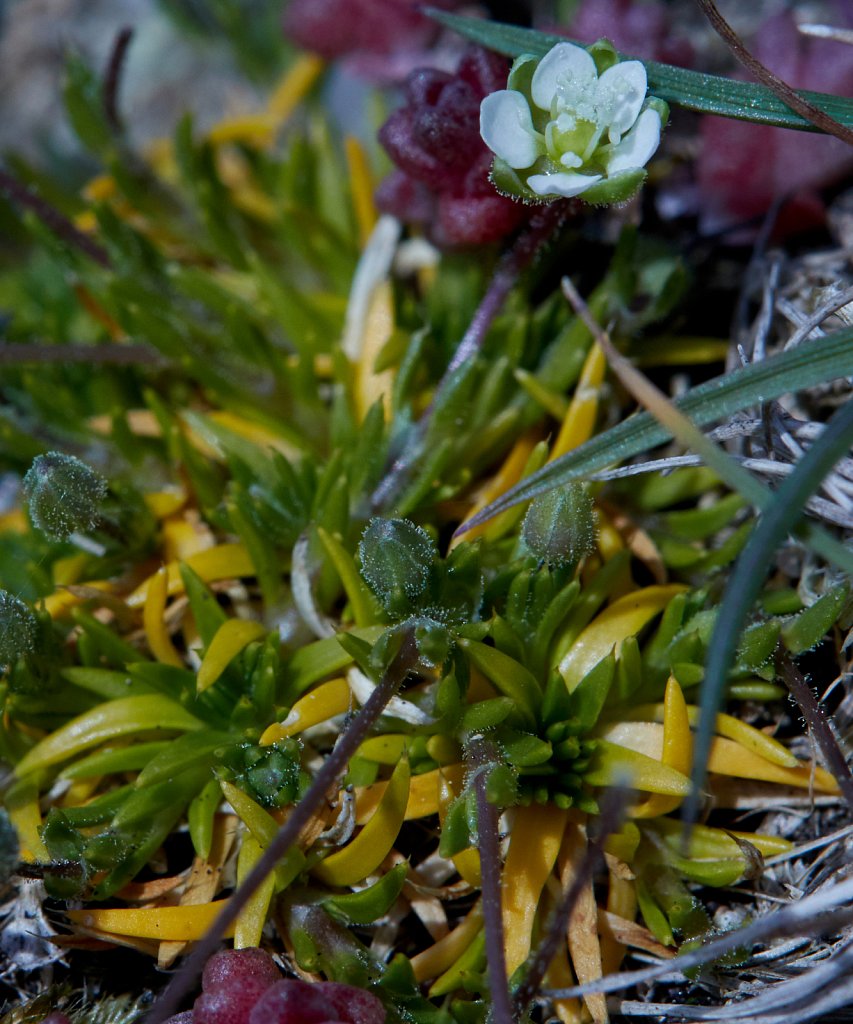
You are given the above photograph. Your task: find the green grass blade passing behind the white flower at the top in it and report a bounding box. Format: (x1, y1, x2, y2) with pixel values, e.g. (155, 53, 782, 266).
(429, 9, 853, 131)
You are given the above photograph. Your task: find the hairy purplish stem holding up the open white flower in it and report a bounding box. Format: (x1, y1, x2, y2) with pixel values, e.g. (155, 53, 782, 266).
(371, 202, 571, 512)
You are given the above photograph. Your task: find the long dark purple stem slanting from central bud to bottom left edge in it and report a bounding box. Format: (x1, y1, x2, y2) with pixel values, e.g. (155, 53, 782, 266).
(147, 631, 418, 1024)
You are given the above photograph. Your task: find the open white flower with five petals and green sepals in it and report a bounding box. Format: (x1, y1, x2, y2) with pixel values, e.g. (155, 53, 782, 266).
(480, 42, 667, 203)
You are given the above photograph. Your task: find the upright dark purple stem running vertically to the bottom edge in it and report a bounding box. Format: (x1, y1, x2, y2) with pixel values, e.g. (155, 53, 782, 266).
(468, 737, 514, 1024)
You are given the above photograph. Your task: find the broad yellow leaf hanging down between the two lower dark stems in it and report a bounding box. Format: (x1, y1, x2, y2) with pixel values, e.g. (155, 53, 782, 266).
(501, 804, 566, 975)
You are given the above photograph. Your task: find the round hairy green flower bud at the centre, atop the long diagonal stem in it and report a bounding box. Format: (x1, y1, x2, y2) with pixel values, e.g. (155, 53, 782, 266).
(358, 517, 437, 615)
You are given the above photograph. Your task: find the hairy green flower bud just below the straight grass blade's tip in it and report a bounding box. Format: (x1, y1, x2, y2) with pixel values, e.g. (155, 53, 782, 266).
(521, 481, 595, 567)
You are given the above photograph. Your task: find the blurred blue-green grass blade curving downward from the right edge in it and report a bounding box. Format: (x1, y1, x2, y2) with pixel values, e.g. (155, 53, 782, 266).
(684, 401, 853, 820)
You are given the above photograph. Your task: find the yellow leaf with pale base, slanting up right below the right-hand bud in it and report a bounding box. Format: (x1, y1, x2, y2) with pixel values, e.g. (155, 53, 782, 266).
(559, 584, 687, 693)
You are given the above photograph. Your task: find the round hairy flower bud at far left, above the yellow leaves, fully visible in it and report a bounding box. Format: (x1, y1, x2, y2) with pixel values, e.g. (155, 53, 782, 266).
(24, 452, 106, 541)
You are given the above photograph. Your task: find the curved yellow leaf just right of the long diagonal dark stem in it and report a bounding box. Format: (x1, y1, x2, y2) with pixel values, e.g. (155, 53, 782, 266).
(313, 758, 409, 886)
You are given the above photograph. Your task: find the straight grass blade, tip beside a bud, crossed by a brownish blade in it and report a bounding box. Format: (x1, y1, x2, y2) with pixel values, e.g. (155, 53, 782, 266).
(465, 328, 853, 529)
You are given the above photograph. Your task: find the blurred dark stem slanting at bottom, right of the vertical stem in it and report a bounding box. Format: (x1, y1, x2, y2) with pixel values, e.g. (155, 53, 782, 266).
(513, 787, 627, 1020)
